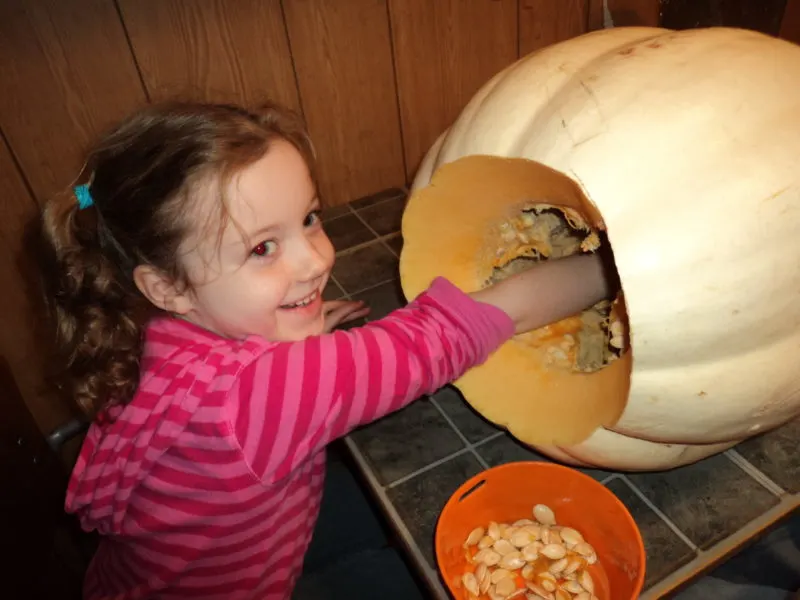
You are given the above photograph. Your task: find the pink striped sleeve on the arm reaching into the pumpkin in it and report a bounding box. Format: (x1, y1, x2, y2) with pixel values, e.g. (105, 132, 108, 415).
(230, 278, 514, 483)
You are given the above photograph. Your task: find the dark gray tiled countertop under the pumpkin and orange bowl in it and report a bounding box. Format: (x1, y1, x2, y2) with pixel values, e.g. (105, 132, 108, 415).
(324, 190, 800, 600)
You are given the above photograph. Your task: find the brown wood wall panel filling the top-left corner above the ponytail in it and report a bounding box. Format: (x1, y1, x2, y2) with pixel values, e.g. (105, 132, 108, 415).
(0, 0, 145, 202)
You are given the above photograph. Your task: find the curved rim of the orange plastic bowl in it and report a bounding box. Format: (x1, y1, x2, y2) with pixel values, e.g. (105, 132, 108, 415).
(433, 460, 647, 598)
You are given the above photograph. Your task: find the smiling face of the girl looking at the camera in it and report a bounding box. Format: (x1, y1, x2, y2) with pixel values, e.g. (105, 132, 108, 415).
(178, 140, 334, 341)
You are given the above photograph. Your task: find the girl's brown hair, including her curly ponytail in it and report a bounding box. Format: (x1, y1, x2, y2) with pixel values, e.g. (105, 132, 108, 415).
(43, 102, 314, 418)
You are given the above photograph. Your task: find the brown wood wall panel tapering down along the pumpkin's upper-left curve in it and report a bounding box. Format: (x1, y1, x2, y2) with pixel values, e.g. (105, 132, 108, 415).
(389, 0, 518, 180)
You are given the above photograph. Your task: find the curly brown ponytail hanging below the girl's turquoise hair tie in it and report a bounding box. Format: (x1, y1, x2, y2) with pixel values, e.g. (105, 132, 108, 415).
(43, 188, 143, 417)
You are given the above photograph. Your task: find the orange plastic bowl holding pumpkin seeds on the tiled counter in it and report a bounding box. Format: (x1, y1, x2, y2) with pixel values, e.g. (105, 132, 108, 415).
(436, 461, 645, 600)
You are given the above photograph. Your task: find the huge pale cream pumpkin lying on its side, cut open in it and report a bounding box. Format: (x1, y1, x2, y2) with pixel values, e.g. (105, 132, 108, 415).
(400, 27, 800, 470)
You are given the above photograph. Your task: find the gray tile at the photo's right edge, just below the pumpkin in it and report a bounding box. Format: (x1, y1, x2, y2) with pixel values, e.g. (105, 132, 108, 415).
(736, 419, 800, 493)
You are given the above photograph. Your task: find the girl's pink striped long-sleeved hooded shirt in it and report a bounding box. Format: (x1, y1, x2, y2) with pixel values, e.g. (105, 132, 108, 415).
(66, 279, 513, 600)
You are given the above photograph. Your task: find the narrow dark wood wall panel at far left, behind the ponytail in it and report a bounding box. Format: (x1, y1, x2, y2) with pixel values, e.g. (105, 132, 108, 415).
(0, 138, 70, 433)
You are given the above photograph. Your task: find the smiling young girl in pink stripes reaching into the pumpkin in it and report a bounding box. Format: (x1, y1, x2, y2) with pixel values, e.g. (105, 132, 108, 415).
(45, 104, 611, 600)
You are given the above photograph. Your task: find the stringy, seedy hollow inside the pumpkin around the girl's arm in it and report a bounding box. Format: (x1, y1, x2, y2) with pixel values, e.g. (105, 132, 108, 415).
(485, 203, 628, 373)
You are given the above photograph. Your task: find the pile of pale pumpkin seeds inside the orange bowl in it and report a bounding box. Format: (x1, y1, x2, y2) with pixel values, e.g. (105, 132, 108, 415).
(461, 504, 599, 600)
